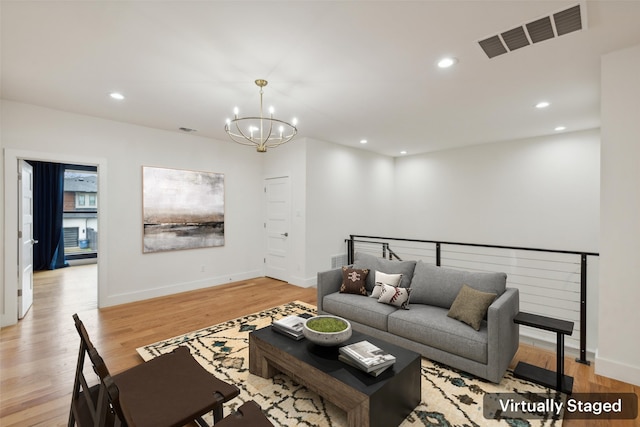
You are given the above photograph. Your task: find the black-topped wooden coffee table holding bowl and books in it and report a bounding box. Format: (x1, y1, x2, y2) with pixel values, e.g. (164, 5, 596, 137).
(249, 326, 421, 427)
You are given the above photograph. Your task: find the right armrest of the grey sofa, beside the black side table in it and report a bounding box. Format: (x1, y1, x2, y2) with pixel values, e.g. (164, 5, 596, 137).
(487, 288, 520, 382)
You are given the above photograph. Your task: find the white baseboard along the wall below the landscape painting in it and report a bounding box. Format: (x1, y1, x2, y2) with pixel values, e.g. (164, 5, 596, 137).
(100, 270, 262, 308)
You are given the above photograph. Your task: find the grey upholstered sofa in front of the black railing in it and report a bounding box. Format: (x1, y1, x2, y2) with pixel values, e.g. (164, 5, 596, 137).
(317, 253, 519, 383)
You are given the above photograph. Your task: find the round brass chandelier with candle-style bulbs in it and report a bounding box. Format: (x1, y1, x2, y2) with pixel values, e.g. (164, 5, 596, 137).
(224, 79, 298, 153)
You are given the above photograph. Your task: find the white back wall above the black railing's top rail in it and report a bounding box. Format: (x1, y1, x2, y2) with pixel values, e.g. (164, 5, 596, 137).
(394, 130, 600, 252)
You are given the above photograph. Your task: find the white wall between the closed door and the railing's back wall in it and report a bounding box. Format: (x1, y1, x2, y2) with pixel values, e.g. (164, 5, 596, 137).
(264, 138, 394, 287)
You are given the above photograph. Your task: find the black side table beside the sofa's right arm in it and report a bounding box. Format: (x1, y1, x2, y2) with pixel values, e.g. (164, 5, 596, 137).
(513, 312, 573, 394)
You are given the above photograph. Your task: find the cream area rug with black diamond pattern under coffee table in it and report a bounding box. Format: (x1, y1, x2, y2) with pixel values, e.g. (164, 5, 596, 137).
(137, 301, 562, 427)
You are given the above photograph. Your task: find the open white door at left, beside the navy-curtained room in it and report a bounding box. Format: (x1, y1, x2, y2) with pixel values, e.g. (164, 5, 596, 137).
(18, 160, 35, 319)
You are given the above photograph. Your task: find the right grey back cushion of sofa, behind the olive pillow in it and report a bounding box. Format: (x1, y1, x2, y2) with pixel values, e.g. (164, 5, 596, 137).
(411, 261, 507, 309)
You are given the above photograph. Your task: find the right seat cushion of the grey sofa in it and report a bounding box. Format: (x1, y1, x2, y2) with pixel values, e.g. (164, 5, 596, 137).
(388, 304, 488, 364)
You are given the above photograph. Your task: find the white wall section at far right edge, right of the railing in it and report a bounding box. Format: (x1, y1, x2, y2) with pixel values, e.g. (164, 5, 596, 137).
(595, 45, 640, 385)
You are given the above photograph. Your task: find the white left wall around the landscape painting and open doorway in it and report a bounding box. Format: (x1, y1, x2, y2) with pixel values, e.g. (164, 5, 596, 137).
(0, 101, 263, 324)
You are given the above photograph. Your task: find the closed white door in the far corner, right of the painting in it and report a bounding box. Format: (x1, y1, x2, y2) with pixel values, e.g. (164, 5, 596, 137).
(264, 176, 291, 282)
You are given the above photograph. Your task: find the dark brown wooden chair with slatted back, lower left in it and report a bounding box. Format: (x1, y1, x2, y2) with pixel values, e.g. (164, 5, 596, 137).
(69, 314, 239, 427)
